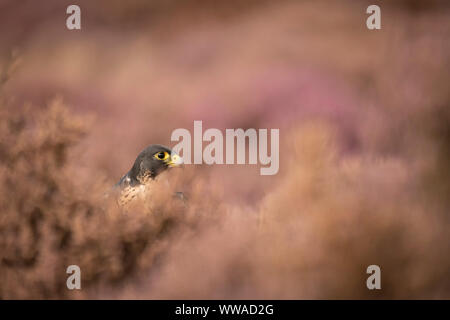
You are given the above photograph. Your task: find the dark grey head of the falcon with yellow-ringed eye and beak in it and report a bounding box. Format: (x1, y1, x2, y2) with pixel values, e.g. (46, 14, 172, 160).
(117, 144, 183, 186)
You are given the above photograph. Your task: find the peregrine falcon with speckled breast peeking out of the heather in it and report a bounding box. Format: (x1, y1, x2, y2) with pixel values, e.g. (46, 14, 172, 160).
(115, 144, 183, 206)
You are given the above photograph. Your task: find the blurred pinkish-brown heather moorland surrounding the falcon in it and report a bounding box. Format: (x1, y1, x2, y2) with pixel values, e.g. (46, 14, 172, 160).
(0, 0, 450, 299)
